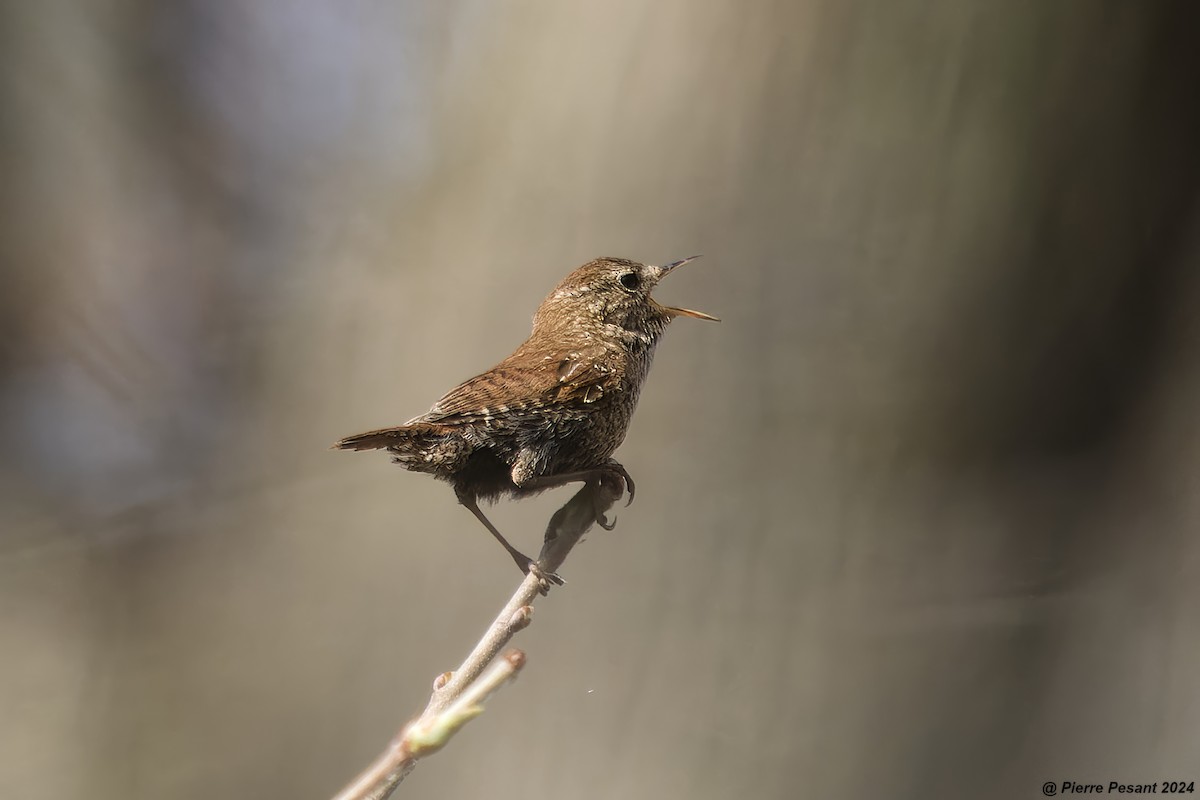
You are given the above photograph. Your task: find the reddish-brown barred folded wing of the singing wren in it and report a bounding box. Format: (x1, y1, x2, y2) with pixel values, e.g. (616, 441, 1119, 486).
(418, 347, 612, 425)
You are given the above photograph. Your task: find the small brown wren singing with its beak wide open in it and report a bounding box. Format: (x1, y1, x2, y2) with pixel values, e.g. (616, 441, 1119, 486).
(334, 255, 718, 587)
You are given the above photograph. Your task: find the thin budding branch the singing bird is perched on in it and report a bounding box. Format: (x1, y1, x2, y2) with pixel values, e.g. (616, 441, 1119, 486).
(334, 480, 624, 800)
